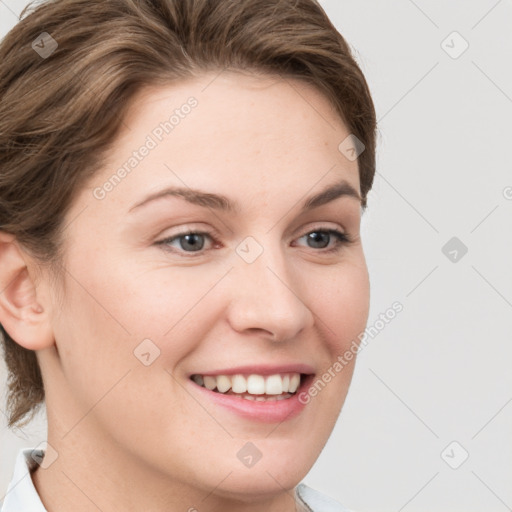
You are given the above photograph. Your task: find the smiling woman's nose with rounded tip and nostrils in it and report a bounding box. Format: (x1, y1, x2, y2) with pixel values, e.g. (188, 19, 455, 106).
(228, 241, 314, 341)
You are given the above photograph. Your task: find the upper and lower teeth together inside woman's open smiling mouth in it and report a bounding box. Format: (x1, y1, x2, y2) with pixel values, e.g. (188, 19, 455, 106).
(190, 372, 306, 402)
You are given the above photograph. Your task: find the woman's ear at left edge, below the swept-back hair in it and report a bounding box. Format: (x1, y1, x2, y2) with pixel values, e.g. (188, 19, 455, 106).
(0, 231, 54, 350)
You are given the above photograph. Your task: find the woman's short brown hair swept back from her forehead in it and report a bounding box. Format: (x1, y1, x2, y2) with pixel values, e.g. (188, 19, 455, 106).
(0, 0, 376, 427)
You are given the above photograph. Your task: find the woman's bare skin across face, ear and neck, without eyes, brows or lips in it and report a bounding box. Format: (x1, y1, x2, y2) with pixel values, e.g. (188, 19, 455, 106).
(0, 71, 369, 512)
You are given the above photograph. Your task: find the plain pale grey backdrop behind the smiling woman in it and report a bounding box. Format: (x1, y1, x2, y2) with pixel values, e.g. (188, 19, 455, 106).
(0, 0, 512, 512)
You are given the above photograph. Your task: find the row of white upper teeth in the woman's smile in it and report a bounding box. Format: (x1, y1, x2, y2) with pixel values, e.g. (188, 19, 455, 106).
(192, 373, 300, 395)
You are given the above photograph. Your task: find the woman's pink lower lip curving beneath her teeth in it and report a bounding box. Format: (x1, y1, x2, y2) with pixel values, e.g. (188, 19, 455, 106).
(190, 375, 314, 423)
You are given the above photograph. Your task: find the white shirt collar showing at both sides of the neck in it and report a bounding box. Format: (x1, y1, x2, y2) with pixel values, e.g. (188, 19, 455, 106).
(0, 448, 350, 512)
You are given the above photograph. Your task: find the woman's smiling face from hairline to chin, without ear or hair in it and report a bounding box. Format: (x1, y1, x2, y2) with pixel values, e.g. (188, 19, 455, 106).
(38, 72, 369, 509)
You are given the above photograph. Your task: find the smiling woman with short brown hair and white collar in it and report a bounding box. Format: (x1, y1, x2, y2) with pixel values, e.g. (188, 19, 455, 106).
(0, 0, 376, 512)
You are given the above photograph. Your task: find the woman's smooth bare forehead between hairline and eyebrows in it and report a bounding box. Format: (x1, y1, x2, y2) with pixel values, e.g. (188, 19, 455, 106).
(78, 72, 359, 216)
